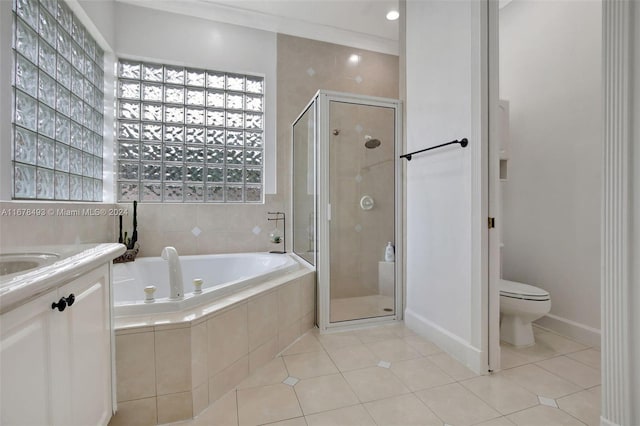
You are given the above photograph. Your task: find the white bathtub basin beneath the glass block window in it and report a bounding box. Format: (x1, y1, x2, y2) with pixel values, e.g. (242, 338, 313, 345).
(113, 253, 301, 317)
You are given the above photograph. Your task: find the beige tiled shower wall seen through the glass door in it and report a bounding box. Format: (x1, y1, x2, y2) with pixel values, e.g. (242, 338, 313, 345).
(329, 103, 395, 298)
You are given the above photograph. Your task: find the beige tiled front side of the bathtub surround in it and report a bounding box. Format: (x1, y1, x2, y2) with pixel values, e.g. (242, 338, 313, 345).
(110, 271, 315, 426)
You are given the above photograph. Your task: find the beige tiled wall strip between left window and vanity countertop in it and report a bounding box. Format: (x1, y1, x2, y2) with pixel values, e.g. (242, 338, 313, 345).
(0, 201, 117, 250)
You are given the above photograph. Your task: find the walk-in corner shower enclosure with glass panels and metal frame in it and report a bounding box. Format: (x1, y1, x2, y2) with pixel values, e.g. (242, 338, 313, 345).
(292, 91, 402, 331)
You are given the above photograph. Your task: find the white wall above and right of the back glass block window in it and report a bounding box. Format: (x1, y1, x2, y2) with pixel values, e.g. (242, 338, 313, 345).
(116, 2, 277, 194)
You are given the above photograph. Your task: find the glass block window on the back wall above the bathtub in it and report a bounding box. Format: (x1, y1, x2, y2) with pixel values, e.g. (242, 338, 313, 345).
(116, 60, 264, 203)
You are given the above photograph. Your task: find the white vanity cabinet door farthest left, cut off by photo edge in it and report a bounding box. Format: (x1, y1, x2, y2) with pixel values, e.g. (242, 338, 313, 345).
(0, 290, 58, 425)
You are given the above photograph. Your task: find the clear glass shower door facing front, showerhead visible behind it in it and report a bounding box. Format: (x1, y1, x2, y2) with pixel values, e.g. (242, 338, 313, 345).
(329, 101, 395, 323)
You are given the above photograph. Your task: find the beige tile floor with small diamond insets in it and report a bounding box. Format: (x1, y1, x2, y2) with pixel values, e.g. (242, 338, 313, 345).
(169, 324, 600, 426)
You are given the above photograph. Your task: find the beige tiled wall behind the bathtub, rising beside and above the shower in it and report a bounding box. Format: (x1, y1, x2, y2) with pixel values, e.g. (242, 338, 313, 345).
(125, 34, 399, 256)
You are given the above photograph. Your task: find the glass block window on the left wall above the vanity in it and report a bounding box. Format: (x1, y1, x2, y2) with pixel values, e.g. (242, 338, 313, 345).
(12, 0, 104, 201)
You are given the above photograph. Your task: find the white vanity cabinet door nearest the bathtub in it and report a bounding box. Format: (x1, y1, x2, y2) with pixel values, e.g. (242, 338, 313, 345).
(58, 266, 111, 426)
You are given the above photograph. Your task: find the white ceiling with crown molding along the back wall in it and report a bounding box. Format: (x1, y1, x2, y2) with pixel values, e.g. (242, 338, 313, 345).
(119, 0, 399, 55)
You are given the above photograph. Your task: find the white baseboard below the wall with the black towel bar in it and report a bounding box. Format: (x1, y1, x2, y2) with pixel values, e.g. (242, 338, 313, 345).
(404, 308, 488, 374)
